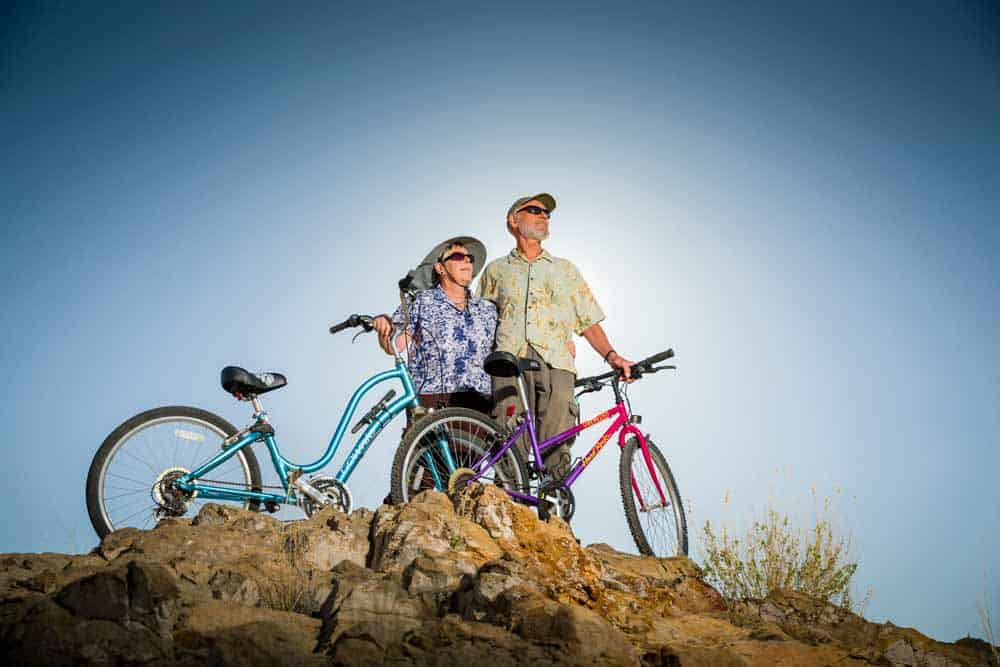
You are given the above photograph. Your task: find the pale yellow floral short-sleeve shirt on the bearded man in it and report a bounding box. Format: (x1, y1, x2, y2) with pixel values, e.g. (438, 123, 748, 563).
(477, 248, 604, 373)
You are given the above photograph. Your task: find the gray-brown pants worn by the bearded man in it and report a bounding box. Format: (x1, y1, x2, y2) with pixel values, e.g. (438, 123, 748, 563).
(493, 347, 580, 477)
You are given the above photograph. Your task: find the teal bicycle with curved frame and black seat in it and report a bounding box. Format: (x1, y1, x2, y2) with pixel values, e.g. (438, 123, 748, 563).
(87, 315, 417, 538)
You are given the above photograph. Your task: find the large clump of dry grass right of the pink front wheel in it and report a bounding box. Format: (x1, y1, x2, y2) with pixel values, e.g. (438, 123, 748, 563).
(701, 492, 872, 613)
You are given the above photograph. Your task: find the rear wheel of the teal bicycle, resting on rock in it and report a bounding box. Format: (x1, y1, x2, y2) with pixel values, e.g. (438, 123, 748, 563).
(87, 406, 261, 538)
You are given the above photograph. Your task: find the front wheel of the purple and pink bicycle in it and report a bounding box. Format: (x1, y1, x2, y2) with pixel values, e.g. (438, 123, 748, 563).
(618, 436, 687, 558)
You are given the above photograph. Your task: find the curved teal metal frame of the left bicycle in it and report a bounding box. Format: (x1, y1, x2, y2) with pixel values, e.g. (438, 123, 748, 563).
(175, 356, 417, 503)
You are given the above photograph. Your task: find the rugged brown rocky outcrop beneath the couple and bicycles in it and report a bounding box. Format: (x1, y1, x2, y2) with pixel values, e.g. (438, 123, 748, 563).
(0, 486, 990, 667)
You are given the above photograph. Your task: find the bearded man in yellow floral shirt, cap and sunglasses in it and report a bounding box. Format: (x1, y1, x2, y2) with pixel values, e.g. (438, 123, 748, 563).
(478, 193, 632, 477)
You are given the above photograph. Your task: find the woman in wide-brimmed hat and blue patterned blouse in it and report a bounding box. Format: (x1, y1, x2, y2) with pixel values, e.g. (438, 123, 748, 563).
(373, 236, 497, 413)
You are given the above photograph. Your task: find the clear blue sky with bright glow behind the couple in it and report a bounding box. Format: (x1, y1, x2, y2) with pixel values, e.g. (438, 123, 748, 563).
(0, 0, 1000, 640)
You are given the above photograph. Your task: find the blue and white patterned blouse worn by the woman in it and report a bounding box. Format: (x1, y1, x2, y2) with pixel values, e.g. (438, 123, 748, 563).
(392, 285, 497, 398)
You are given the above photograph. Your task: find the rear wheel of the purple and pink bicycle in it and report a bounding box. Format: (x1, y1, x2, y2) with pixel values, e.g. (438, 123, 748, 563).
(390, 408, 528, 504)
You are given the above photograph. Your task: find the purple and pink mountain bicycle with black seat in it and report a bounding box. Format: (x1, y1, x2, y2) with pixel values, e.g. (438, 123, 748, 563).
(391, 349, 688, 557)
